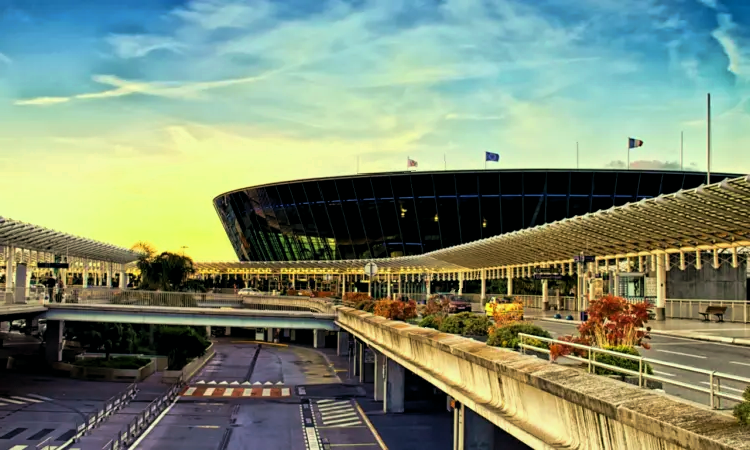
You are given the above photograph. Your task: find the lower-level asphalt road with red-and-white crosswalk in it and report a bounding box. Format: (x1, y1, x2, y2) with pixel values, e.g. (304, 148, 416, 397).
(131, 338, 388, 450)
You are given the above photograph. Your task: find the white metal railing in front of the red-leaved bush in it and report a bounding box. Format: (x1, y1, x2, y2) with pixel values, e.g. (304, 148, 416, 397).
(518, 333, 750, 409)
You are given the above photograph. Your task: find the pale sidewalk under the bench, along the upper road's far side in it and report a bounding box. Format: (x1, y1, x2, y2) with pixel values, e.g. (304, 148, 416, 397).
(527, 308, 750, 347)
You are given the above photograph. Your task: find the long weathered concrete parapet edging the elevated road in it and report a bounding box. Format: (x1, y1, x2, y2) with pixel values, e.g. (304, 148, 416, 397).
(337, 307, 750, 450)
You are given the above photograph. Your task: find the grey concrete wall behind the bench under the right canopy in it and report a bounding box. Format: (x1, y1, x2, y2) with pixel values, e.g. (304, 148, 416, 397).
(667, 253, 748, 300)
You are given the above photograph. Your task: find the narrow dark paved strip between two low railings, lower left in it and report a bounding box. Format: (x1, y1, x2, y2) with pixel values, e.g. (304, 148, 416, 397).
(73, 372, 170, 450)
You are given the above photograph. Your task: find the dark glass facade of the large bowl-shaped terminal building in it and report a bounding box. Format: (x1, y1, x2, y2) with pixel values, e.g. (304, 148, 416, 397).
(214, 170, 742, 261)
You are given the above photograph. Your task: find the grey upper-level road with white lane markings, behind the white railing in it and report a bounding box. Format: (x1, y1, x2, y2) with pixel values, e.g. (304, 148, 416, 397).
(535, 321, 750, 408)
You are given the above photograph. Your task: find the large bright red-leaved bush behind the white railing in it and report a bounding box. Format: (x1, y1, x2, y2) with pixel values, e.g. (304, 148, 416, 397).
(550, 295, 651, 361)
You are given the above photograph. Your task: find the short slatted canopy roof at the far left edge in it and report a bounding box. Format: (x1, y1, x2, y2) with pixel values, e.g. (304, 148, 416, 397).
(0, 217, 138, 264)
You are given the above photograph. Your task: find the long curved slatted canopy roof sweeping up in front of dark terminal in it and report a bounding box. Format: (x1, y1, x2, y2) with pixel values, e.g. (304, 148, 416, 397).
(196, 175, 750, 273)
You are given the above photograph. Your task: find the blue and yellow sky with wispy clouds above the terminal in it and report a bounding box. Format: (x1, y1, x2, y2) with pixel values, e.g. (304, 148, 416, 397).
(0, 0, 750, 261)
